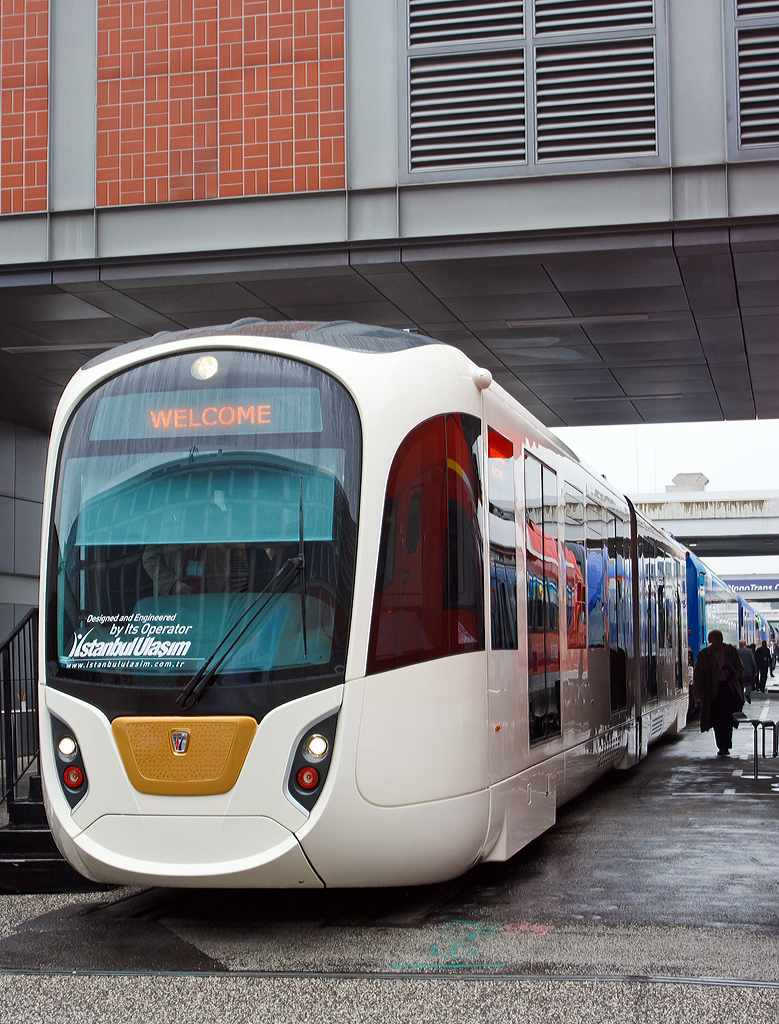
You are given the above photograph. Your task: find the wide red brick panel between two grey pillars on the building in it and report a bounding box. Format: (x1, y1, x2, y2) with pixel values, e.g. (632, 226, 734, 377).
(96, 0, 344, 206)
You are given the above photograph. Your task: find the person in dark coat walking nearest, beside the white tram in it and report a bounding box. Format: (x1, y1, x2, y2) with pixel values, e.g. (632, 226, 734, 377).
(692, 630, 744, 757)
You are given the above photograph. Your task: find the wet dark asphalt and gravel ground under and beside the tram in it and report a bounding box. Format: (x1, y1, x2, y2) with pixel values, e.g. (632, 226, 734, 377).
(0, 694, 779, 1024)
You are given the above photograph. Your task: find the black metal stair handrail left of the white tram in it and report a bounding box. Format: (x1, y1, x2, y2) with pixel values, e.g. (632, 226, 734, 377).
(0, 608, 39, 810)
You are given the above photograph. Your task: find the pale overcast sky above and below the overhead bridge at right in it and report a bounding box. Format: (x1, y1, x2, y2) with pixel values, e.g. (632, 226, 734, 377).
(555, 420, 779, 575)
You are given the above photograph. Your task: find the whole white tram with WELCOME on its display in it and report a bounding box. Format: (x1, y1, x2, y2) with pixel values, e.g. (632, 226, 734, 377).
(40, 321, 688, 887)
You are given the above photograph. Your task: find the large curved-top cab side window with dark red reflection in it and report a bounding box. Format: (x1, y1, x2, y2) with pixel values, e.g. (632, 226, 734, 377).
(367, 414, 484, 674)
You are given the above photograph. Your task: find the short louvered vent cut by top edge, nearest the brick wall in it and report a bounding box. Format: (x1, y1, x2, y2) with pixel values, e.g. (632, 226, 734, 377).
(408, 0, 523, 46)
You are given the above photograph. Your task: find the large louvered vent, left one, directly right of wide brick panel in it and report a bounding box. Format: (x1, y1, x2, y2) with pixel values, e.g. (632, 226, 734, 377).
(410, 50, 525, 171)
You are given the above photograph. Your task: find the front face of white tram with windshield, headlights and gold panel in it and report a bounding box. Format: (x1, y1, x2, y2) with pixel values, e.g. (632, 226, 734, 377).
(40, 341, 362, 888)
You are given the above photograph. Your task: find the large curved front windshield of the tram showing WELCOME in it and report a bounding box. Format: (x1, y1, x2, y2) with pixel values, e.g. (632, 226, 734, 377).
(48, 351, 360, 690)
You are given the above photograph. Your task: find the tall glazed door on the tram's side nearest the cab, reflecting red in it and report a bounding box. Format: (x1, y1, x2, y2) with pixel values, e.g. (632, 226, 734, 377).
(525, 453, 560, 743)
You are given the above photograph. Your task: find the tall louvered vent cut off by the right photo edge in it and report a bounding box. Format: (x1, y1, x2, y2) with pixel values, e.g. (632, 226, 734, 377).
(738, 27, 779, 145)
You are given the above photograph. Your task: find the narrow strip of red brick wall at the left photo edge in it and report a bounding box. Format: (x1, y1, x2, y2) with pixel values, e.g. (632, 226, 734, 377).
(0, 0, 49, 213)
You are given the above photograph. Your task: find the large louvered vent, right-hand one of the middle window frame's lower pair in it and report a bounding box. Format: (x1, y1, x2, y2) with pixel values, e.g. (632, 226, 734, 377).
(535, 39, 657, 161)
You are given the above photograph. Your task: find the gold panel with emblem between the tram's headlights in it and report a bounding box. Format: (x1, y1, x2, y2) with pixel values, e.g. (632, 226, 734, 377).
(112, 715, 257, 797)
